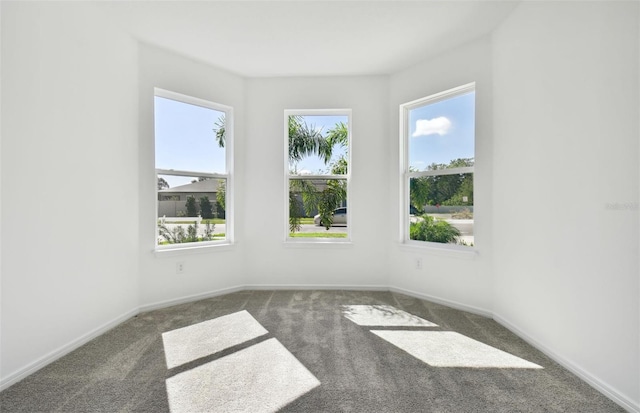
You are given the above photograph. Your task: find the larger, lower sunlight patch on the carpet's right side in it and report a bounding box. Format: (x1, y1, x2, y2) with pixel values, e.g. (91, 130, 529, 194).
(371, 330, 542, 369)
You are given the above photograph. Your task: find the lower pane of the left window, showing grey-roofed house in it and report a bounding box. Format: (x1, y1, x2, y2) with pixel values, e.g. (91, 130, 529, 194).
(157, 175, 226, 245)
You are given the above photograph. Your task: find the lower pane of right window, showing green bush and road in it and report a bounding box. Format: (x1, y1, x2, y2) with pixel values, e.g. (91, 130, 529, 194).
(409, 173, 474, 246)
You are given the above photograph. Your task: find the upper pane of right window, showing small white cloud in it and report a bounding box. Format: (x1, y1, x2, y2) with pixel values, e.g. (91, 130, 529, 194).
(407, 92, 475, 171)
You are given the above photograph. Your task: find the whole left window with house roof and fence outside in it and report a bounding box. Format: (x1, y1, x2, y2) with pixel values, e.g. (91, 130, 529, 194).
(154, 88, 233, 249)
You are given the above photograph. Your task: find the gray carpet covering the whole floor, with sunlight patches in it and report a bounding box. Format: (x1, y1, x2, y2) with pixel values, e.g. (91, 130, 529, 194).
(0, 291, 624, 413)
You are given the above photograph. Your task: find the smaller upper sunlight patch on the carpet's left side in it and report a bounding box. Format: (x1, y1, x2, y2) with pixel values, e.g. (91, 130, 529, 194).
(162, 311, 268, 369)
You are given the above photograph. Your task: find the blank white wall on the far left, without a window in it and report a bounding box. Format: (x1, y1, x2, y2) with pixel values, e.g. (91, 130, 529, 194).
(0, 2, 138, 385)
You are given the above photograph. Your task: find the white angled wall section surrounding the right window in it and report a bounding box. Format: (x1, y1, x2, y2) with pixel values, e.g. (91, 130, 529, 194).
(386, 38, 492, 314)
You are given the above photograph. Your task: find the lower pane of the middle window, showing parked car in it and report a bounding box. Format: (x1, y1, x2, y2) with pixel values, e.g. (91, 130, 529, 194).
(289, 179, 348, 238)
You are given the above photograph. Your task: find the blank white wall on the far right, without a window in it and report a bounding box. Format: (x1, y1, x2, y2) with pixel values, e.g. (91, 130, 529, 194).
(493, 2, 640, 411)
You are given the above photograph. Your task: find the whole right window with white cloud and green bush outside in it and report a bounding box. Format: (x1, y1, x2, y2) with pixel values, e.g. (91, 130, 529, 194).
(400, 83, 475, 247)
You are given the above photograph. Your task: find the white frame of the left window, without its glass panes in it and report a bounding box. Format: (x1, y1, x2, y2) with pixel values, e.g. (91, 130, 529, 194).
(153, 87, 235, 251)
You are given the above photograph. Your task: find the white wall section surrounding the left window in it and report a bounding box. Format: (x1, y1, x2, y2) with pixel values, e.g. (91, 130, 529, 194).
(138, 44, 246, 308)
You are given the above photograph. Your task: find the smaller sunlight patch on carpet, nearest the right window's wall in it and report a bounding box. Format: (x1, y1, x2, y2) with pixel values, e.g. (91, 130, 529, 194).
(342, 305, 438, 327)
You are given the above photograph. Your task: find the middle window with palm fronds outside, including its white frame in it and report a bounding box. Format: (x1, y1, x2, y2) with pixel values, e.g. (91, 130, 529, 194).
(285, 110, 351, 242)
